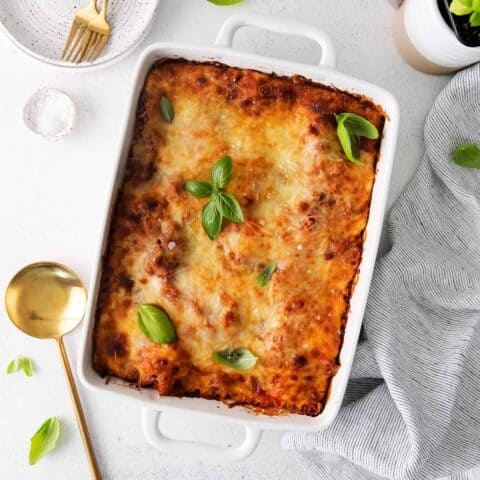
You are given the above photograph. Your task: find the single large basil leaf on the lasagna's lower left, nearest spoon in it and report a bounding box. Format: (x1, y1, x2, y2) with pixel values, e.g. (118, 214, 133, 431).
(137, 303, 178, 344)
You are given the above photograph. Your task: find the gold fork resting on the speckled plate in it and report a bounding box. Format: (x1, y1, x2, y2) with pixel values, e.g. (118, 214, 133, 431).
(62, 0, 110, 63)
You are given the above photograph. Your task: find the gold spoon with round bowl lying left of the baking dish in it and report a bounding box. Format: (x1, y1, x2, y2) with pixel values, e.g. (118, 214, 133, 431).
(5, 262, 101, 480)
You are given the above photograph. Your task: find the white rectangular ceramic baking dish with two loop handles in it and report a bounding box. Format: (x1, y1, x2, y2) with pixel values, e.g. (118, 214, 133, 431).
(78, 15, 399, 461)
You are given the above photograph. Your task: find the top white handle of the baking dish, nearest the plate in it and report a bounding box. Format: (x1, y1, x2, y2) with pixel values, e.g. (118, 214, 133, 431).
(215, 13, 335, 68)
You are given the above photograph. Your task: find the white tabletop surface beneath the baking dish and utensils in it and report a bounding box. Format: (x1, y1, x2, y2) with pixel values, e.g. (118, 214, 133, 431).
(0, 0, 448, 480)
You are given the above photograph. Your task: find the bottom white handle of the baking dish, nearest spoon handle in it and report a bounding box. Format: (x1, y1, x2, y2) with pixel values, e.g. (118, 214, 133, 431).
(142, 408, 262, 463)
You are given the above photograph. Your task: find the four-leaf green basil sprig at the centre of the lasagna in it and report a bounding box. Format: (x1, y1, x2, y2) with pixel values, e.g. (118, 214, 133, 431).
(185, 156, 245, 240)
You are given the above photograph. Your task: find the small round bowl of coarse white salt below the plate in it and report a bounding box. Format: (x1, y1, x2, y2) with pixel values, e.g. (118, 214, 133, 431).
(23, 88, 75, 142)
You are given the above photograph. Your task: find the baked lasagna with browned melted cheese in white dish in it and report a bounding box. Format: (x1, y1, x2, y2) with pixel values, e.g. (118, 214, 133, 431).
(93, 60, 385, 416)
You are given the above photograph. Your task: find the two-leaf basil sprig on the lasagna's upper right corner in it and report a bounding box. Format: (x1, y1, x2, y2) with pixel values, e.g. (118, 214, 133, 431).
(335, 113, 378, 164)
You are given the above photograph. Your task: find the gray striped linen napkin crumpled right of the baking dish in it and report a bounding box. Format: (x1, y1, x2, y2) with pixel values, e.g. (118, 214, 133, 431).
(282, 64, 480, 480)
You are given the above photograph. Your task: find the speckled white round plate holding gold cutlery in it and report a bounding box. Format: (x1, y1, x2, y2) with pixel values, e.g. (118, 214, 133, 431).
(0, 0, 158, 70)
